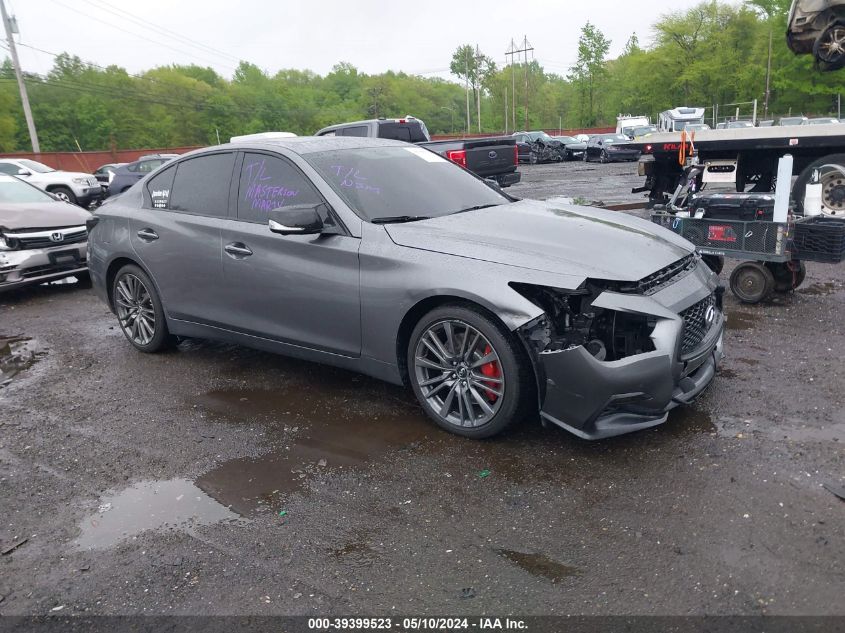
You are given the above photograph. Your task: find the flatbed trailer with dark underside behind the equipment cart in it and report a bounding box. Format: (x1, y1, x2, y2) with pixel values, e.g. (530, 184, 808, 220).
(629, 123, 845, 217)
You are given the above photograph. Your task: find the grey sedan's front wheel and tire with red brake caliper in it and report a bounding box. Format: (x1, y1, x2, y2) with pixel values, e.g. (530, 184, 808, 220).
(408, 306, 530, 438)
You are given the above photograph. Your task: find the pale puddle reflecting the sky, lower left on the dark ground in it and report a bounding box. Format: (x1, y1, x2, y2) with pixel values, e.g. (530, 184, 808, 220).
(75, 479, 238, 549)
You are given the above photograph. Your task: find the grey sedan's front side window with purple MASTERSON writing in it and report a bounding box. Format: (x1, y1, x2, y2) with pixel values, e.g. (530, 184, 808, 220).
(238, 153, 323, 224)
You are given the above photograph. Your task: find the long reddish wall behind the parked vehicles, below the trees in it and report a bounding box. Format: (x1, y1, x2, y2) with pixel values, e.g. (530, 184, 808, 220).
(5, 127, 616, 174)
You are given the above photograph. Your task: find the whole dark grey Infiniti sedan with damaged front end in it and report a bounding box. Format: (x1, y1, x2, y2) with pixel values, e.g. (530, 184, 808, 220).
(89, 137, 724, 439)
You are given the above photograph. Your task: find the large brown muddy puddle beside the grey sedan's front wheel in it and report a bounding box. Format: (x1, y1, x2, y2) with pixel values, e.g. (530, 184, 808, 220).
(196, 385, 436, 515)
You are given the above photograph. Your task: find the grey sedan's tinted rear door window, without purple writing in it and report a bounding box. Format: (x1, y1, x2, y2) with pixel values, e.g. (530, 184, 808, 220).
(170, 152, 235, 217)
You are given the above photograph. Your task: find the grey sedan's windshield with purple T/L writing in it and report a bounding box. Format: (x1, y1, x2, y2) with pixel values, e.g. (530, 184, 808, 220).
(303, 147, 510, 220)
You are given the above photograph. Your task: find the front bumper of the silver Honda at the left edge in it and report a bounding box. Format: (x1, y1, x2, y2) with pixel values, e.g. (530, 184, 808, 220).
(0, 242, 88, 292)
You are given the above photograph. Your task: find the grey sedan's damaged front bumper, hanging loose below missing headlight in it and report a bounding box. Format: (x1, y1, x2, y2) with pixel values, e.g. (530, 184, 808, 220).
(535, 276, 725, 440)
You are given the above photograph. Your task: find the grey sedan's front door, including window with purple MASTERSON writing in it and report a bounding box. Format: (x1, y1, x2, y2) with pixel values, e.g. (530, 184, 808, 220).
(222, 152, 361, 356)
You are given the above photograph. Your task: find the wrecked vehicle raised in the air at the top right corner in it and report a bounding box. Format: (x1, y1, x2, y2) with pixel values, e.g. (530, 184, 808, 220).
(786, 0, 845, 70)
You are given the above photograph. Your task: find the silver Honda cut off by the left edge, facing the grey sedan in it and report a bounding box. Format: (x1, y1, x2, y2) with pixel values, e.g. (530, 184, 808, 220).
(0, 174, 91, 292)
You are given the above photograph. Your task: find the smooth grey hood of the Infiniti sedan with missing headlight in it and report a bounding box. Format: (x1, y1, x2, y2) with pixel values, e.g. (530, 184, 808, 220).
(385, 200, 694, 281)
